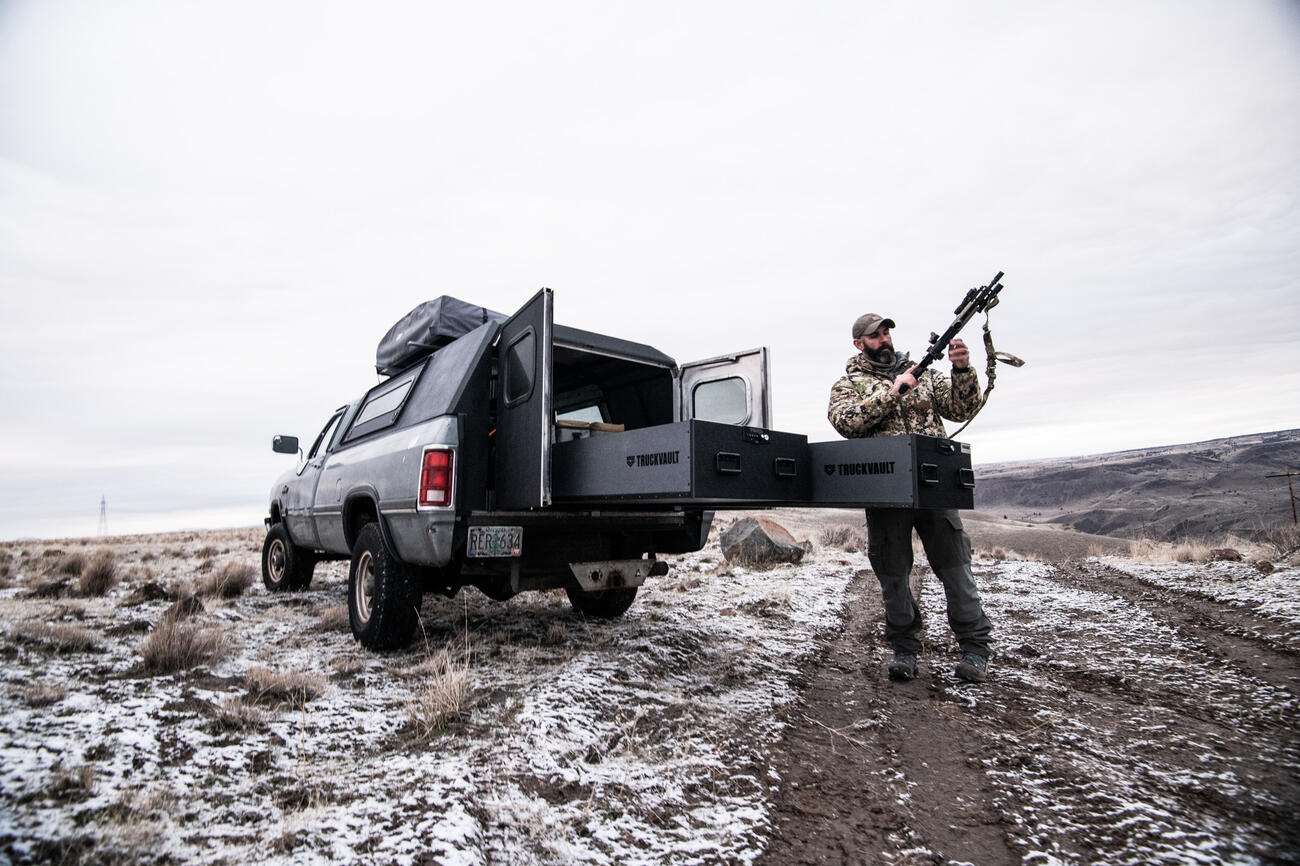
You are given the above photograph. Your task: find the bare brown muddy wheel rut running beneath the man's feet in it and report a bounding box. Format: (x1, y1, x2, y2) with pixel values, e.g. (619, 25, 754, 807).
(757, 570, 1023, 866)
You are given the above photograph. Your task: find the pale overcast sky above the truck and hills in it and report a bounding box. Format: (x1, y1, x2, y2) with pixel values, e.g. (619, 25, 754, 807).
(0, 0, 1300, 538)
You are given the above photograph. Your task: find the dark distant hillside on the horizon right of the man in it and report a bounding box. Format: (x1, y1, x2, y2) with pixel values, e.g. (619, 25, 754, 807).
(975, 429, 1300, 541)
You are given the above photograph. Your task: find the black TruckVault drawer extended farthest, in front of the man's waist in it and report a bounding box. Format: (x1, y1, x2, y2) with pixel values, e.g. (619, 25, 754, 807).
(809, 434, 975, 508)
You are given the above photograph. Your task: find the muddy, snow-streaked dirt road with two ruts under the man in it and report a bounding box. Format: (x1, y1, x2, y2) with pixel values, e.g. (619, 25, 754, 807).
(758, 560, 1300, 866)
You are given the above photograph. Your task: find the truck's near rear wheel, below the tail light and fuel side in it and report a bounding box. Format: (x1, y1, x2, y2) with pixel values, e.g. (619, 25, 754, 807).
(347, 523, 420, 650)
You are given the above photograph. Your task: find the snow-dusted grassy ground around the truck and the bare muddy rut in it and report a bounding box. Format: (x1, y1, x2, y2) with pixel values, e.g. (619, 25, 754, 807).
(0, 522, 1300, 865)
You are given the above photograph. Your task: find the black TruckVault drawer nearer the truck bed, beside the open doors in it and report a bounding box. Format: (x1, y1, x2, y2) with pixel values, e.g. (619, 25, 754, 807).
(551, 420, 813, 506)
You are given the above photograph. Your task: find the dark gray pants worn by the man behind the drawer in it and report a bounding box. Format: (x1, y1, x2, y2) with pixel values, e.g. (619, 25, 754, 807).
(867, 508, 992, 658)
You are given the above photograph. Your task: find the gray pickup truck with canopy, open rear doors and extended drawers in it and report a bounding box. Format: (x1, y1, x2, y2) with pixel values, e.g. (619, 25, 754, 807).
(261, 289, 974, 649)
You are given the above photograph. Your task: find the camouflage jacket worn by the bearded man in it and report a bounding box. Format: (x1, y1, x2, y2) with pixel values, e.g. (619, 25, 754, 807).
(827, 355, 980, 440)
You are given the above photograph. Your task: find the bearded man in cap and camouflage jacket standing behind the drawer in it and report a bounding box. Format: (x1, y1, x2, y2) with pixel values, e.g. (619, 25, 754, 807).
(827, 313, 992, 683)
